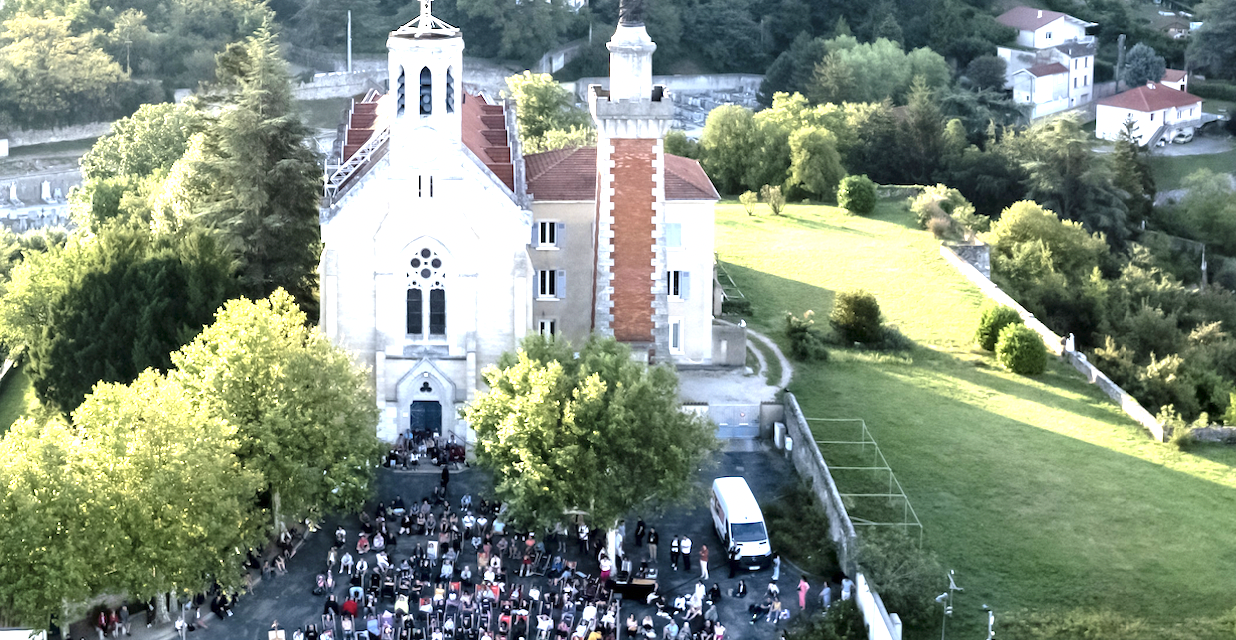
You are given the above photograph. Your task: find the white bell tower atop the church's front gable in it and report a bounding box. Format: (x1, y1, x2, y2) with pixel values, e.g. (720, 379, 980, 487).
(387, 0, 464, 170)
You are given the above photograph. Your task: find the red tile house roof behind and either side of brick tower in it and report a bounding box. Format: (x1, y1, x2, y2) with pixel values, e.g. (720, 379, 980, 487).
(524, 147, 721, 201)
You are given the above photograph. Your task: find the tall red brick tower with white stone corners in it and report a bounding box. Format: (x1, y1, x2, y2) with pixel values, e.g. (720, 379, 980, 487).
(588, 0, 674, 362)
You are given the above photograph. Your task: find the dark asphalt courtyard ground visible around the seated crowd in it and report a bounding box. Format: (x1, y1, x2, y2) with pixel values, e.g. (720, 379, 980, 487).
(72, 448, 837, 640)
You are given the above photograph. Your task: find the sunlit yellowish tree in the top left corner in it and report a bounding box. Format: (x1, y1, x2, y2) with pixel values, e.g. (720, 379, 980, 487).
(0, 15, 129, 126)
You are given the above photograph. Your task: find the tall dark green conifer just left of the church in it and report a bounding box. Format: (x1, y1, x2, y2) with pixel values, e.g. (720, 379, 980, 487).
(189, 26, 321, 309)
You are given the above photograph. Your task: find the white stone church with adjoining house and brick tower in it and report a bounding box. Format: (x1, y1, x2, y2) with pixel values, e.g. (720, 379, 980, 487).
(319, 0, 731, 441)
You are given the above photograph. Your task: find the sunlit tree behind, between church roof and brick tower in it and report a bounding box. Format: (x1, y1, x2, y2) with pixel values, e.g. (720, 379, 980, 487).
(507, 70, 595, 153)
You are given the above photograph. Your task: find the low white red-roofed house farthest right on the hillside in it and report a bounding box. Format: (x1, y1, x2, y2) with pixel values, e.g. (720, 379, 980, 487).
(1094, 83, 1201, 146)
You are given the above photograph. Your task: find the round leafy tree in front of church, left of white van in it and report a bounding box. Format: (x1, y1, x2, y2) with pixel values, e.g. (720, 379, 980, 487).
(464, 335, 716, 529)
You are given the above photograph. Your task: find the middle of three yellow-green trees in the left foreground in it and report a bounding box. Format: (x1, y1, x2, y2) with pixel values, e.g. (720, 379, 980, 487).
(73, 371, 262, 599)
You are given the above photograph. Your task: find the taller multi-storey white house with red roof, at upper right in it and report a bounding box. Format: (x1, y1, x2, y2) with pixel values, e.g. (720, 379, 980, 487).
(996, 6, 1096, 117)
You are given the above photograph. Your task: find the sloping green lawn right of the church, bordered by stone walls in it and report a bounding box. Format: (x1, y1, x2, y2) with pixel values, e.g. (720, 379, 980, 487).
(717, 203, 1236, 638)
